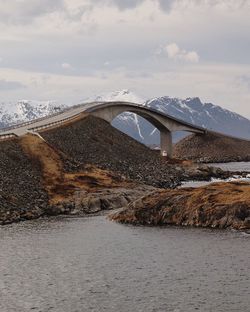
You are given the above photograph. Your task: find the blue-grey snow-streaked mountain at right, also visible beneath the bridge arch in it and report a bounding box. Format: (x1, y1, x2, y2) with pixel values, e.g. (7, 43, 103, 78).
(113, 96, 250, 145)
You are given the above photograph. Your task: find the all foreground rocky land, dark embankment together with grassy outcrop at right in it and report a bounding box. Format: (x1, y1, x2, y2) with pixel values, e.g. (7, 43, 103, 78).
(0, 114, 250, 229)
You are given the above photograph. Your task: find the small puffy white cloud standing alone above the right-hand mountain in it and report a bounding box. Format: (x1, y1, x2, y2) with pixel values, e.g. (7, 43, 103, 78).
(159, 43, 200, 63)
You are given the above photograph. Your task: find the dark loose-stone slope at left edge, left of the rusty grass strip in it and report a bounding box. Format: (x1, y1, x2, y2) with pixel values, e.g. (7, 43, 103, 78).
(0, 139, 48, 224)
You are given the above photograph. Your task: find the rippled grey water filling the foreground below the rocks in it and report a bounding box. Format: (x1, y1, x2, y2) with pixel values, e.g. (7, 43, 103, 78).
(0, 216, 250, 312)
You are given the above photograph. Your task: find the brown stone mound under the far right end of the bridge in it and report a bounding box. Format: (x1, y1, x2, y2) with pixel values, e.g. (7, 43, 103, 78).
(174, 133, 250, 163)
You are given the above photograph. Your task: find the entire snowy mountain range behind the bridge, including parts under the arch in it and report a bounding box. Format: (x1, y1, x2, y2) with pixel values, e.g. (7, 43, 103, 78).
(0, 90, 250, 145)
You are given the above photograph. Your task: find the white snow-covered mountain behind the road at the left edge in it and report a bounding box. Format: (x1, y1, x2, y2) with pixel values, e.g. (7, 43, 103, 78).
(0, 100, 66, 128)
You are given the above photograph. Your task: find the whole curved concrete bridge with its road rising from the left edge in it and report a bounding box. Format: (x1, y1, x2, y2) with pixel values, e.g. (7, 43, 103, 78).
(0, 101, 207, 158)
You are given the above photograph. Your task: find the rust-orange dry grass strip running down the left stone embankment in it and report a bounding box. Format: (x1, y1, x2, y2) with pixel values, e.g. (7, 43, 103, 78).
(20, 134, 131, 204)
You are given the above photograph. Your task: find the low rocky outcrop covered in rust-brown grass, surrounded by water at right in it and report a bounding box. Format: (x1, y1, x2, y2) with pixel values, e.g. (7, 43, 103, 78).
(110, 182, 250, 230)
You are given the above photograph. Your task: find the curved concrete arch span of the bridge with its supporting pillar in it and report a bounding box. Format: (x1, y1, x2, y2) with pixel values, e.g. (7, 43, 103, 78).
(87, 102, 204, 158)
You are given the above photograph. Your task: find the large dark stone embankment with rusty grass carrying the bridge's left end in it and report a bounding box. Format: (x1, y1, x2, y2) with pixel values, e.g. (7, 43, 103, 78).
(0, 115, 248, 224)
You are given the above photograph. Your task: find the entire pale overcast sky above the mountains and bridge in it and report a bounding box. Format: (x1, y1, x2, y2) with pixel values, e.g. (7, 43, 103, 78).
(0, 0, 250, 118)
